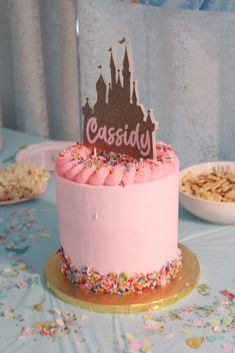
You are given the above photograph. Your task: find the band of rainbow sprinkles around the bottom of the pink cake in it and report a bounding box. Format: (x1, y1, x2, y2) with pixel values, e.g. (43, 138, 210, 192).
(57, 247, 182, 295)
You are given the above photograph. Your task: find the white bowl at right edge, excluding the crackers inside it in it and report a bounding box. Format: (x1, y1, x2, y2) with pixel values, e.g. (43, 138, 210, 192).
(179, 161, 235, 224)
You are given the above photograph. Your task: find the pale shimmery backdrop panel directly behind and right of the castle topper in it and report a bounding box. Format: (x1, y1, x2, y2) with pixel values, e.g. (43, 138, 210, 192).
(78, 0, 235, 166)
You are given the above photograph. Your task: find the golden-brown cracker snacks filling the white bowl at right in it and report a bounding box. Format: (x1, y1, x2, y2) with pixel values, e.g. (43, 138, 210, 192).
(180, 168, 235, 202)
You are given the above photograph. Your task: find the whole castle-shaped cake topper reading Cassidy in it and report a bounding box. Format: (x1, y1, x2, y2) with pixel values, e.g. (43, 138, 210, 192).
(82, 38, 157, 158)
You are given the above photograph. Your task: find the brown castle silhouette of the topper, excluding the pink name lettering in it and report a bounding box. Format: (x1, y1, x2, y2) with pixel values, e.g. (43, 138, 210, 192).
(82, 45, 155, 158)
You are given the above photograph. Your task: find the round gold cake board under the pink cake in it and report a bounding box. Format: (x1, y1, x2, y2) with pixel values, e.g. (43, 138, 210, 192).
(45, 244, 200, 314)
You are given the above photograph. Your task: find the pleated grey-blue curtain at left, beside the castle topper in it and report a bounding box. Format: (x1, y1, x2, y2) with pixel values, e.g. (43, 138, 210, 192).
(0, 0, 80, 140)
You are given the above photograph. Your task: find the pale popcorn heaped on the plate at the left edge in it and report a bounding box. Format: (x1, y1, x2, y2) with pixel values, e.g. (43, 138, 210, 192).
(0, 163, 49, 201)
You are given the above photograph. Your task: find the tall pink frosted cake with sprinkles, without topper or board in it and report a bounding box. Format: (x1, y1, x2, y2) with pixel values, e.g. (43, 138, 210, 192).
(55, 143, 181, 294)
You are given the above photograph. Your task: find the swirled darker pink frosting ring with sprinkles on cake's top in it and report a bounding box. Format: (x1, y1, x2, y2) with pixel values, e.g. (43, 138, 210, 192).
(55, 142, 179, 186)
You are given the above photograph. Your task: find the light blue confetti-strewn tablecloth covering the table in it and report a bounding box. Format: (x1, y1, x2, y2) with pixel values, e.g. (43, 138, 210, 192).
(0, 129, 235, 353)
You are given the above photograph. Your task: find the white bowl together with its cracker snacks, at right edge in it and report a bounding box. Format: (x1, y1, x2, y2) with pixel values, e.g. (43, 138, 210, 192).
(179, 161, 235, 224)
